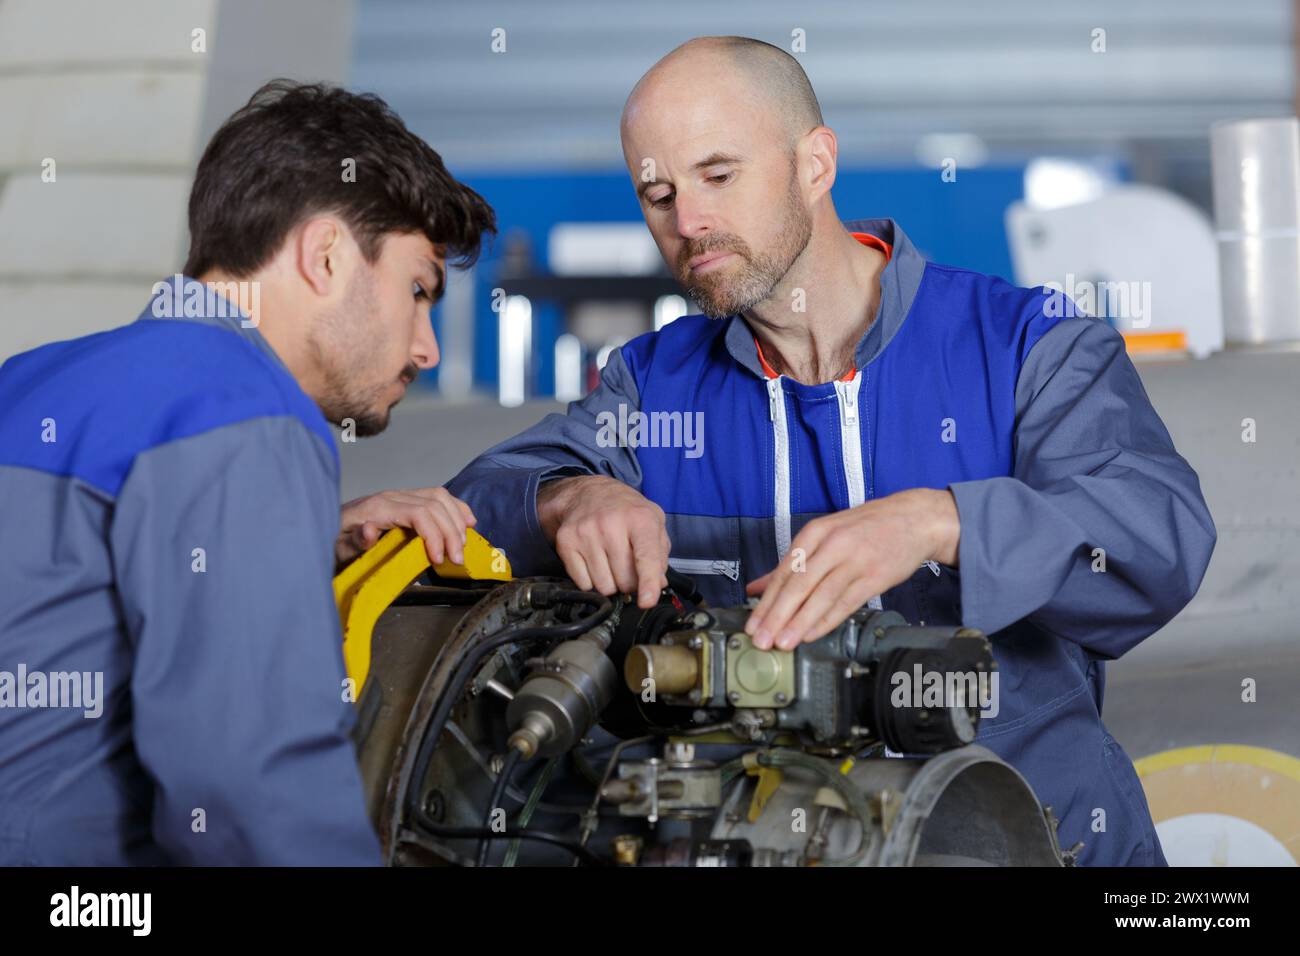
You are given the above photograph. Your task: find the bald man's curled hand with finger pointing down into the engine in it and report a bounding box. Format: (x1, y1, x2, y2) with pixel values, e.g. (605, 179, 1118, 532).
(537, 475, 671, 607)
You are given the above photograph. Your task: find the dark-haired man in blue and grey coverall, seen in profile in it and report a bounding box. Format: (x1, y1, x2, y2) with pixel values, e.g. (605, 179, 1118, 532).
(0, 81, 495, 865)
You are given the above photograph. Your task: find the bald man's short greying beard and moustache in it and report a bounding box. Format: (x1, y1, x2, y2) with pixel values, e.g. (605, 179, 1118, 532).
(677, 176, 813, 319)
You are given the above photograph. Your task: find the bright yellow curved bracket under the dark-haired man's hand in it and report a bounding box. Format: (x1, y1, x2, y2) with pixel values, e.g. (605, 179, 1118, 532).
(334, 528, 511, 702)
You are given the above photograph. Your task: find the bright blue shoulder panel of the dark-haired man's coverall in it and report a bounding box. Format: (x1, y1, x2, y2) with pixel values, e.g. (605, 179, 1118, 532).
(0, 319, 338, 496)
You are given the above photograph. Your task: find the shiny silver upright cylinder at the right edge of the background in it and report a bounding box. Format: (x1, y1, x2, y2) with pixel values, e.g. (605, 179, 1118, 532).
(1210, 117, 1300, 346)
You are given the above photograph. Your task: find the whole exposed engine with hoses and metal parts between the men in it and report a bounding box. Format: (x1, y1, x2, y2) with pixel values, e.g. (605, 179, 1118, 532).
(356, 579, 1071, 866)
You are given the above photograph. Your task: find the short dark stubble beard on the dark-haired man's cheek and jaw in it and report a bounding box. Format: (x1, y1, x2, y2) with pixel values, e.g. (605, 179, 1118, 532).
(311, 267, 420, 438)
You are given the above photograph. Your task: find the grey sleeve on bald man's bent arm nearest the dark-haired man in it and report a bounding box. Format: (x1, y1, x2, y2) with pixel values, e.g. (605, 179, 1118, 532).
(447, 349, 641, 575)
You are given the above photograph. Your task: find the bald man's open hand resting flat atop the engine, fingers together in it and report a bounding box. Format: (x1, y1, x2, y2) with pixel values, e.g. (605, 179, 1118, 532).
(745, 488, 961, 650)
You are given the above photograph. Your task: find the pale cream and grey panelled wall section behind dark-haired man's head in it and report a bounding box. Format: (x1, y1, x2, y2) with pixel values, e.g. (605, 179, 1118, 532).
(0, 0, 352, 359)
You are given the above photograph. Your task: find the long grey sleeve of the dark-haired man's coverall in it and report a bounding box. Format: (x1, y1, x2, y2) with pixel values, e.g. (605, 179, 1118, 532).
(111, 418, 380, 865)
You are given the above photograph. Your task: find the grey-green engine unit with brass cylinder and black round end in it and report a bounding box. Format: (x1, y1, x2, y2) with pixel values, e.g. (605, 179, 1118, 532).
(611, 607, 997, 753)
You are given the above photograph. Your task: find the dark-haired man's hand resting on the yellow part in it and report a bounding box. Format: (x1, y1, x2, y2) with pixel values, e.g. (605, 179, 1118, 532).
(334, 488, 476, 567)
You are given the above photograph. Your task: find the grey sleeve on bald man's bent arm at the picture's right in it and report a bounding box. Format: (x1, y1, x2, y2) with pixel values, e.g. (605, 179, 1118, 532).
(949, 319, 1216, 658)
